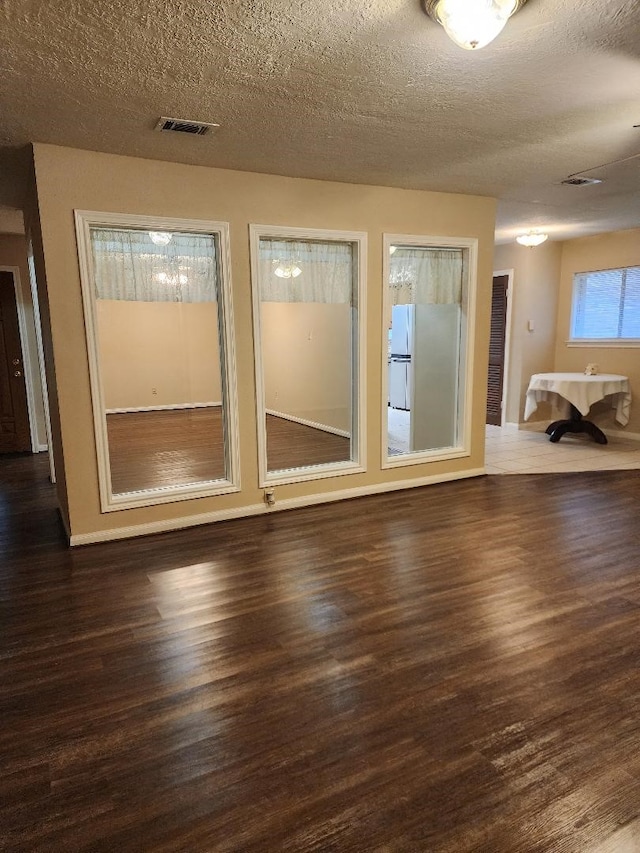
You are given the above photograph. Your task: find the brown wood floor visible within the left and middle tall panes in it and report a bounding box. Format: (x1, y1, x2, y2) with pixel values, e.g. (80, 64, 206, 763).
(107, 406, 351, 494)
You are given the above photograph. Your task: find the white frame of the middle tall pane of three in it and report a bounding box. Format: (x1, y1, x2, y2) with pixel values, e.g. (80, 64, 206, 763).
(249, 225, 367, 488)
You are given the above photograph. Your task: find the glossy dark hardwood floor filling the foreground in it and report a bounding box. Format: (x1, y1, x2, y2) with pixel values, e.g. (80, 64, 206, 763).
(0, 454, 640, 853)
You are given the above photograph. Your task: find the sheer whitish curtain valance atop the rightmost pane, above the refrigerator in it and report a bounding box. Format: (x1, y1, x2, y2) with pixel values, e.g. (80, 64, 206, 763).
(389, 246, 463, 305)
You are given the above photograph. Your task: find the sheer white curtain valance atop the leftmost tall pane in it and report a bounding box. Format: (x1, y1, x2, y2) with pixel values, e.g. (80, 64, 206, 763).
(91, 228, 217, 302)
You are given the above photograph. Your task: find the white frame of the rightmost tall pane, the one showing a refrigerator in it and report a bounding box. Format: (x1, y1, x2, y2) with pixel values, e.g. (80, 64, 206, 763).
(381, 234, 478, 468)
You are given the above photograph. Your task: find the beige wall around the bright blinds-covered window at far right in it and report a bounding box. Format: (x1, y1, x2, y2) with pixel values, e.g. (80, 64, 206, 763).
(555, 228, 640, 433)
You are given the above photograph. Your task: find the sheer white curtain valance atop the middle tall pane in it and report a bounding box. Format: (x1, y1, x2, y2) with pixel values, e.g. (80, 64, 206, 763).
(259, 238, 353, 305)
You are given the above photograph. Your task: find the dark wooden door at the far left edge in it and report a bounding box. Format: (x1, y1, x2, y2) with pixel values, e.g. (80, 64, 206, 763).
(0, 271, 31, 453)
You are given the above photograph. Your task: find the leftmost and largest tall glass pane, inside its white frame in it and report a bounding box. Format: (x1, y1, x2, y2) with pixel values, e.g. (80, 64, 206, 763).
(90, 227, 228, 495)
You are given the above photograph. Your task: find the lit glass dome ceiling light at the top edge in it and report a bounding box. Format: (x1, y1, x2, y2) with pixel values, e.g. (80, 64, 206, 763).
(422, 0, 527, 50)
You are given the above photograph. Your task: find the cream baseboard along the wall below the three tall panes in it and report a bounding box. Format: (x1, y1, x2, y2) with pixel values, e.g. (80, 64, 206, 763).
(69, 468, 485, 547)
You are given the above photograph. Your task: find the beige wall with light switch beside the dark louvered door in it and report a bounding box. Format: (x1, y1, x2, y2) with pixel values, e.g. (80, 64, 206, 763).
(493, 241, 562, 423)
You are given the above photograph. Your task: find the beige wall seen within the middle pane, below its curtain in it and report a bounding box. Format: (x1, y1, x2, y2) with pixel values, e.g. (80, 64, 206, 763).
(261, 302, 351, 432)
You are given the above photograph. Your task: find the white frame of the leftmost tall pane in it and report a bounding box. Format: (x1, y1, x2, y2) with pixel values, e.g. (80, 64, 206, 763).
(74, 210, 240, 512)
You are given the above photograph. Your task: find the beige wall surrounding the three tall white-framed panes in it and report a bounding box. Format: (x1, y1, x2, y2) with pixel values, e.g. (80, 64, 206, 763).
(34, 140, 495, 535)
